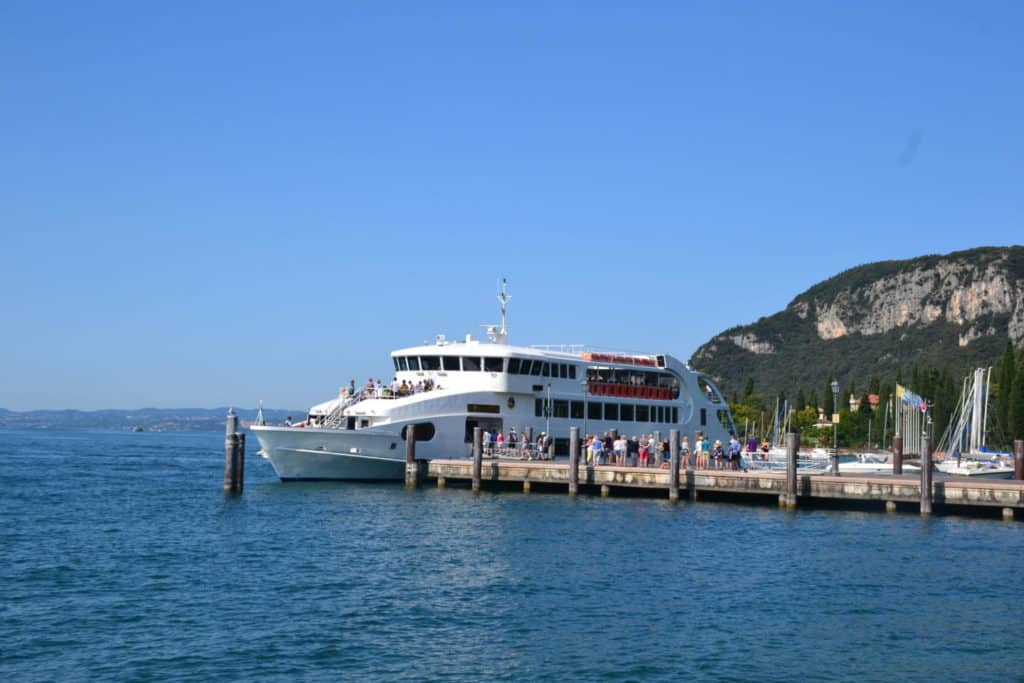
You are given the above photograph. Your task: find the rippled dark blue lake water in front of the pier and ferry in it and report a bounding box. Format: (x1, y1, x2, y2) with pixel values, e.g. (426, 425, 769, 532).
(0, 431, 1024, 681)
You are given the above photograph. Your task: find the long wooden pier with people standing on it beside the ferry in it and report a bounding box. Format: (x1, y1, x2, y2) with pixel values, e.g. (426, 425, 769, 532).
(426, 459, 1024, 519)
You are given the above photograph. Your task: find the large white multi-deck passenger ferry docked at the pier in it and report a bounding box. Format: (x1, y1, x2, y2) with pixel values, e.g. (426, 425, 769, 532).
(251, 288, 735, 481)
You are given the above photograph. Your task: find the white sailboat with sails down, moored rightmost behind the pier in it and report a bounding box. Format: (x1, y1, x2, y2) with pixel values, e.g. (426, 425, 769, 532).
(935, 368, 1014, 479)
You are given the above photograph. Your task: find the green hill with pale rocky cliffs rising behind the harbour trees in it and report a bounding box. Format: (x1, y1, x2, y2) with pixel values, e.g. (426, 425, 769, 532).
(690, 247, 1024, 393)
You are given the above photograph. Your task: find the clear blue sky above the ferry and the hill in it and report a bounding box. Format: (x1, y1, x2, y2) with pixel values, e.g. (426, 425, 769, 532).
(0, 1, 1024, 410)
